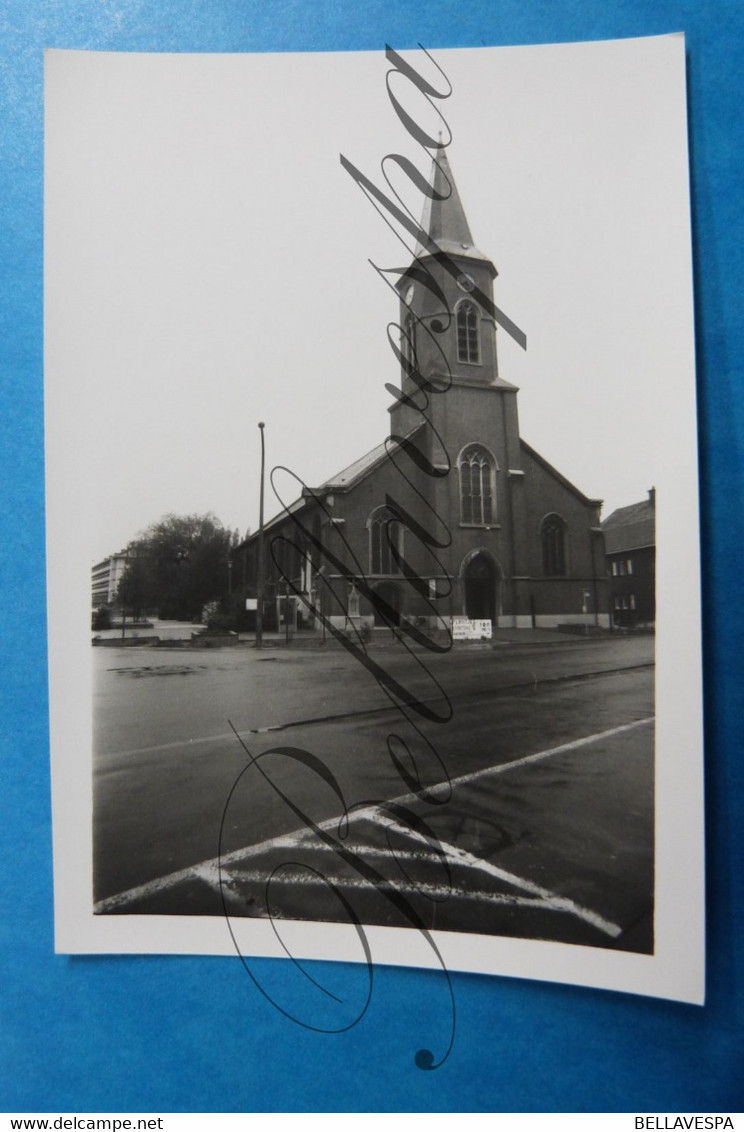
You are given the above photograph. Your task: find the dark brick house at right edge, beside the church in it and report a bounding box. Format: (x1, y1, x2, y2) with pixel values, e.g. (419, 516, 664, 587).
(602, 488, 656, 626)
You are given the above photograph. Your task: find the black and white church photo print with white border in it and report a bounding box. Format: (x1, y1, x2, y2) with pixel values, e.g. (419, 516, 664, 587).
(45, 36, 703, 1002)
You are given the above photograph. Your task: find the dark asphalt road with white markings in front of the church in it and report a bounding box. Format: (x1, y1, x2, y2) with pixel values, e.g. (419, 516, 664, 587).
(94, 637, 653, 951)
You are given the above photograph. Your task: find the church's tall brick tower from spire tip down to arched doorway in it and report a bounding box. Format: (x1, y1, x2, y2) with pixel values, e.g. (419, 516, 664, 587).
(390, 146, 528, 621)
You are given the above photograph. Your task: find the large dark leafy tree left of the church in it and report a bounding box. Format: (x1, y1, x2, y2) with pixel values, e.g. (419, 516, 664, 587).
(117, 514, 237, 620)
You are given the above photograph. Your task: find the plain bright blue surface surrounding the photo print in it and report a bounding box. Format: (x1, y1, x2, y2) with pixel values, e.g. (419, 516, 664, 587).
(0, 0, 744, 1113)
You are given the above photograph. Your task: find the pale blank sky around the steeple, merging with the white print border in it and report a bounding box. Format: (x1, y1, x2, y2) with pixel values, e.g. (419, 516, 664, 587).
(46, 37, 692, 563)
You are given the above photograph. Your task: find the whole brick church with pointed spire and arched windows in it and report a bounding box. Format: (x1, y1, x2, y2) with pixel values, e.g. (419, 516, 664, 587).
(233, 148, 608, 640)
